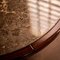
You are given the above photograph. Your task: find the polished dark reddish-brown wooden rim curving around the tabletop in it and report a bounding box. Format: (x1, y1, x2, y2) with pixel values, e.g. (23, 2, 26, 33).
(0, 19, 60, 60)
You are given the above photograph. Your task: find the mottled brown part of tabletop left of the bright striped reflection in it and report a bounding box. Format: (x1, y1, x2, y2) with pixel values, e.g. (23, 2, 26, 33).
(0, 0, 59, 55)
